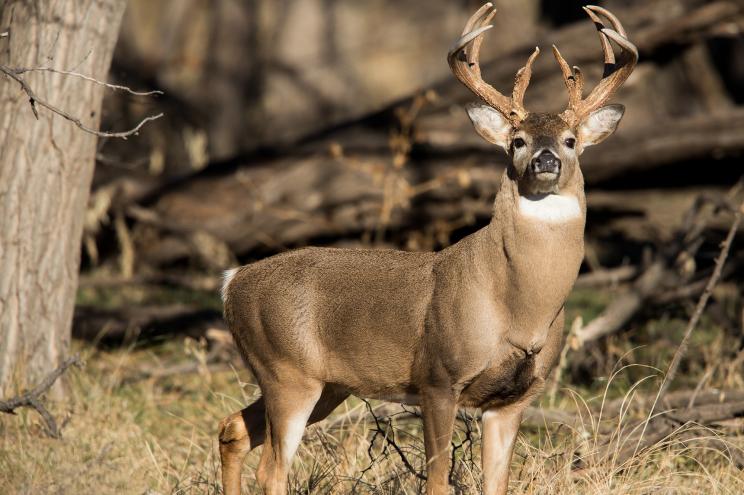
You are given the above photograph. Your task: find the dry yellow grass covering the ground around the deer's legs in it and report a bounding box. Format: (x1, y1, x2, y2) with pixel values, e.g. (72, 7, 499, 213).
(0, 330, 744, 494)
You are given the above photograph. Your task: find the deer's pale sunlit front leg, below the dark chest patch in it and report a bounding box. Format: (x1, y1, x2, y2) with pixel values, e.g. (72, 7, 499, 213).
(481, 406, 523, 495)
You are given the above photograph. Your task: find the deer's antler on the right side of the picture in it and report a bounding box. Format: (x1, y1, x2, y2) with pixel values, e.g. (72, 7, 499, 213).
(553, 5, 638, 126)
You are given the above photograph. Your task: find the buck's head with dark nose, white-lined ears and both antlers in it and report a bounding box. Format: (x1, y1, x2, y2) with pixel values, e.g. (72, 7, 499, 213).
(447, 2, 638, 195)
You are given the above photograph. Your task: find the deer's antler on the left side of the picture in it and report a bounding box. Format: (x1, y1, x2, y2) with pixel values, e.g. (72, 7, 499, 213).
(447, 2, 540, 125)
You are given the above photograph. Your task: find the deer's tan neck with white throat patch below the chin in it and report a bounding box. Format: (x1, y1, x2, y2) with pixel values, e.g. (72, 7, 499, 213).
(472, 167, 586, 342)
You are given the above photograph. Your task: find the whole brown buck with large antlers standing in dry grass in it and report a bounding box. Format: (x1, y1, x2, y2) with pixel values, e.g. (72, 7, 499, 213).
(219, 3, 638, 495)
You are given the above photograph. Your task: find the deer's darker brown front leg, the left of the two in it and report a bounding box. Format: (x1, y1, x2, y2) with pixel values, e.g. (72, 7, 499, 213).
(421, 389, 457, 495)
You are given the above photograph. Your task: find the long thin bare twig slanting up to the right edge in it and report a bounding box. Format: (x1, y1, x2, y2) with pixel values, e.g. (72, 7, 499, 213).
(634, 202, 744, 455)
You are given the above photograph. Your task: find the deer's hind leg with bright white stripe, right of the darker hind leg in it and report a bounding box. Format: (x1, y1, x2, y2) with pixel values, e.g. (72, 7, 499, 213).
(256, 380, 323, 495)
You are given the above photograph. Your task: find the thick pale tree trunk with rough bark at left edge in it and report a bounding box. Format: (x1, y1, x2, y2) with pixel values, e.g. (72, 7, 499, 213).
(0, 0, 125, 396)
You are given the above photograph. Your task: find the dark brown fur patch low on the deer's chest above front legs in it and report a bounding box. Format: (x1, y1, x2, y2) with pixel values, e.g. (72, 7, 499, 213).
(459, 352, 537, 408)
